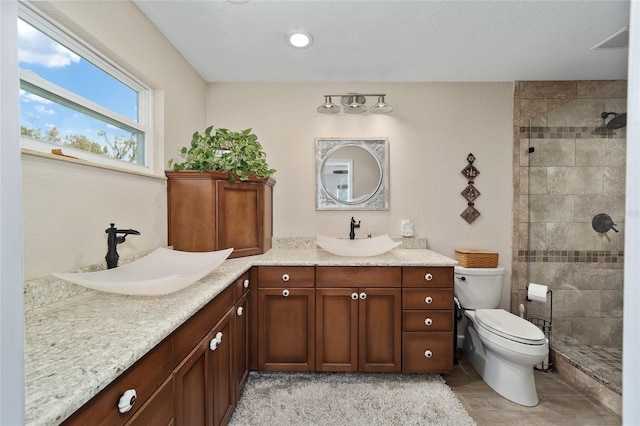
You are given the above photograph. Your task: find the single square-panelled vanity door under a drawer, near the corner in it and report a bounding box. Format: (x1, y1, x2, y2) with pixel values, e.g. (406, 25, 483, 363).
(258, 288, 315, 371)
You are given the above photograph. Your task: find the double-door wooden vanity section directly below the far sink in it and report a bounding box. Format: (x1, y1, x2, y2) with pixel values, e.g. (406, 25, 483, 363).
(315, 266, 402, 372)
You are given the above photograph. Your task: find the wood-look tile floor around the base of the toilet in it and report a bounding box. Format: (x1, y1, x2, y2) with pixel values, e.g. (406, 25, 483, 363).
(443, 359, 622, 426)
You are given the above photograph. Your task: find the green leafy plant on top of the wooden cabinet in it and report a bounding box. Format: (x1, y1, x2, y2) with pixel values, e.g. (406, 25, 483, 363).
(169, 126, 276, 181)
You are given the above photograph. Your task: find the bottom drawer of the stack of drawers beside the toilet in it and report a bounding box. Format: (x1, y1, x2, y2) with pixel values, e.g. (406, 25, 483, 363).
(402, 332, 453, 373)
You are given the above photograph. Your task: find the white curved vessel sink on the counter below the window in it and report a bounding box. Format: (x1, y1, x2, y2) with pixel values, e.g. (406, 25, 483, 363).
(53, 247, 233, 296)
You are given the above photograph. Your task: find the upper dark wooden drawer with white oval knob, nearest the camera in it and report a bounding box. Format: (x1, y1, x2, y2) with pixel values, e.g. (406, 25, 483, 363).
(64, 337, 173, 425)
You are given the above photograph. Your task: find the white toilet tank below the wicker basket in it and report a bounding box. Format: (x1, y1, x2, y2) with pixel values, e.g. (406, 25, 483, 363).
(454, 266, 505, 309)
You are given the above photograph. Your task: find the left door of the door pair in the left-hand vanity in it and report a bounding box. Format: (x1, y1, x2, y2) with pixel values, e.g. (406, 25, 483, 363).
(174, 334, 211, 426)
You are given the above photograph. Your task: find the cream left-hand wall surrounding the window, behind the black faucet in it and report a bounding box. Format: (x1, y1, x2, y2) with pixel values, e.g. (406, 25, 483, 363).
(22, 1, 206, 279)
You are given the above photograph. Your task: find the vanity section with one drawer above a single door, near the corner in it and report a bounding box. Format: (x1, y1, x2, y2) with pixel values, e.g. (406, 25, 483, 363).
(257, 266, 315, 371)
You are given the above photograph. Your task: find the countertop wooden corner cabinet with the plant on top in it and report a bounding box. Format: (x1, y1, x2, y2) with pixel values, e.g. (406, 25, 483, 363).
(165, 171, 275, 258)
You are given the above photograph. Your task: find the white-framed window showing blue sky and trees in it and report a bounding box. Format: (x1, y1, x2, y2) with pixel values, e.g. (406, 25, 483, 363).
(18, 3, 152, 172)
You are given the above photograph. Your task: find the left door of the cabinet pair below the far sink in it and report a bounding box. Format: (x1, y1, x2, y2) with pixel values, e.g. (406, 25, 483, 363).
(316, 288, 360, 371)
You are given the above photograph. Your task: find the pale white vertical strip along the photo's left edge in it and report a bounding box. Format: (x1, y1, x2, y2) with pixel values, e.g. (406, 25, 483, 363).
(0, 0, 24, 425)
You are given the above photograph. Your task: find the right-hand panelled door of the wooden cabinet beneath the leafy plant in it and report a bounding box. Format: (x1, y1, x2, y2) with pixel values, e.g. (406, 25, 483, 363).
(216, 180, 265, 257)
